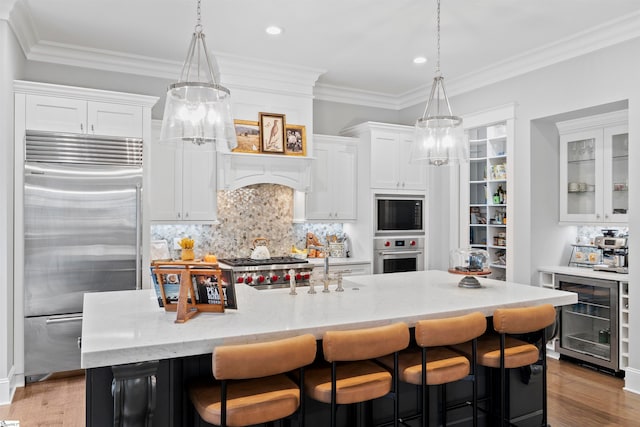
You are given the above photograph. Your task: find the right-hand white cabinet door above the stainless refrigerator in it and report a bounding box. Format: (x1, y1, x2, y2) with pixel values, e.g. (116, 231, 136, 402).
(86, 101, 142, 138)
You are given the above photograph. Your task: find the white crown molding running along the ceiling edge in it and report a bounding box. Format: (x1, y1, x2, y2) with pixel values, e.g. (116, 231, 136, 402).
(7, 0, 640, 110)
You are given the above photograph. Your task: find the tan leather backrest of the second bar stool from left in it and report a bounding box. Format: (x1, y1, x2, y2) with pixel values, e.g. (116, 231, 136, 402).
(322, 323, 409, 362)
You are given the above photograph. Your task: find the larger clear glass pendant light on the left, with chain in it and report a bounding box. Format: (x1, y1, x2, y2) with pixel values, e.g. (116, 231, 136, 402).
(160, 0, 238, 151)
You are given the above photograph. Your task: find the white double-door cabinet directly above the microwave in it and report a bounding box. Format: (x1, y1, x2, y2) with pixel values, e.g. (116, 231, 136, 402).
(371, 126, 427, 191)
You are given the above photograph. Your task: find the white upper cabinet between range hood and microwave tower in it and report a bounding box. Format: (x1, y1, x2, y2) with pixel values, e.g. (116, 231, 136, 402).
(305, 135, 358, 221)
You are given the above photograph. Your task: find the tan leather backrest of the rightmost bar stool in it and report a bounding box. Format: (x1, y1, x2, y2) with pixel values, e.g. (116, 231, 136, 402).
(493, 304, 556, 334)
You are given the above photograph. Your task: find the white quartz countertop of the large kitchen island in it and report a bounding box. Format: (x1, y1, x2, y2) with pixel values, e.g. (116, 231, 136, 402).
(82, 271, 577, 369)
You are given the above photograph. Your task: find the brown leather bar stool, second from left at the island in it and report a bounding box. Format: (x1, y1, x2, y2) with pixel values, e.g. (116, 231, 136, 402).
(304, 323, 409, 427)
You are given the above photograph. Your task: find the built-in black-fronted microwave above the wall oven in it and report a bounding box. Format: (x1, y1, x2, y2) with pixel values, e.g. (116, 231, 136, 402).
(374, 194, 424, 236)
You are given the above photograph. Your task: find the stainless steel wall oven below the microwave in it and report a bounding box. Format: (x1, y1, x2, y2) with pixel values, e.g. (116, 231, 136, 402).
(373, 237, 425, 274)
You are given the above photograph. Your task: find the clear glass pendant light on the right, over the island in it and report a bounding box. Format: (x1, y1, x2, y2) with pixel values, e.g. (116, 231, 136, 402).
(411, 0, 469, 166)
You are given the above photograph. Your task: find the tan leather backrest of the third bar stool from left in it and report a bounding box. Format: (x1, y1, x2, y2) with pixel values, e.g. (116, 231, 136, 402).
(415, 312, 487, 347)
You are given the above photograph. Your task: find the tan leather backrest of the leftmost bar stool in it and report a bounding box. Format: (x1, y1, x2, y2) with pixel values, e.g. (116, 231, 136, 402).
(211, 334, 317, 380)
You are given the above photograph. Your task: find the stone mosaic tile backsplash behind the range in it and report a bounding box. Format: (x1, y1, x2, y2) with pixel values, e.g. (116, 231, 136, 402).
(151, 184, 343, 258)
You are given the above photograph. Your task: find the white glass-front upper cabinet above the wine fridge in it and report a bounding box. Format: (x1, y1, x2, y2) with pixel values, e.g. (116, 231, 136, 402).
(556, 110, 629, 224)
